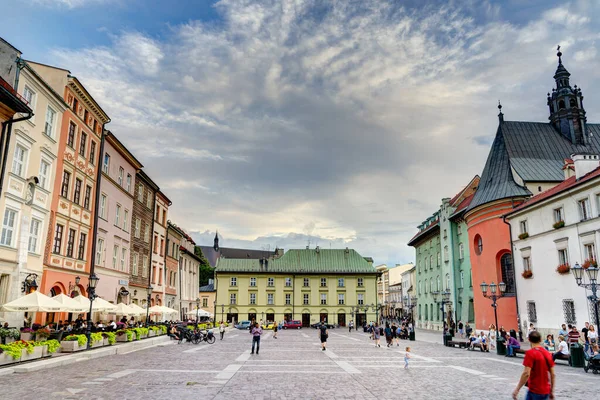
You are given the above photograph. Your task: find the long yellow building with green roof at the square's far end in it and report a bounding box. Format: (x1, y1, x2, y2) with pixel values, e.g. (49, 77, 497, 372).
(215, 247, 377, 327)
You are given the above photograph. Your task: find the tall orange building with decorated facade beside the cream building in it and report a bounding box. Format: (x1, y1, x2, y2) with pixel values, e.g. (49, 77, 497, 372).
(30, 62, 110, 318)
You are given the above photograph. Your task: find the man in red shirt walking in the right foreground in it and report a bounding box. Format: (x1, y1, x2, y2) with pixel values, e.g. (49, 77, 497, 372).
(513, 331, 555, 400)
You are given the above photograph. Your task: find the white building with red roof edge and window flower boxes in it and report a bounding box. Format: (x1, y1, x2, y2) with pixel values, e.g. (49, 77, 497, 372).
(506, 155, 600, 335)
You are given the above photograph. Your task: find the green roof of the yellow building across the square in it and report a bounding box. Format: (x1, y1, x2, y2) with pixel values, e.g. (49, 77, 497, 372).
(216, 249, 377, 274)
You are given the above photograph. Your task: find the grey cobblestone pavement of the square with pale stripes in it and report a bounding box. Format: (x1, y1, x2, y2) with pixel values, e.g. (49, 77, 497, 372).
(0, 329, 600, 400)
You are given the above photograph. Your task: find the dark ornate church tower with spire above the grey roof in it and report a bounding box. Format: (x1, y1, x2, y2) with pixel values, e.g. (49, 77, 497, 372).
(548, 46, 588, 145)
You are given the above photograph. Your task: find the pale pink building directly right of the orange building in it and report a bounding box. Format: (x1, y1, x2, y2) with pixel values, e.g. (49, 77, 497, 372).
(94, 131, 142, 303)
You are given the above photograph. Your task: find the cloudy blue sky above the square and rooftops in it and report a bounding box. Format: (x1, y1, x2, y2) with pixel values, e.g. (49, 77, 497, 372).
(0, 0, 600, 265)
